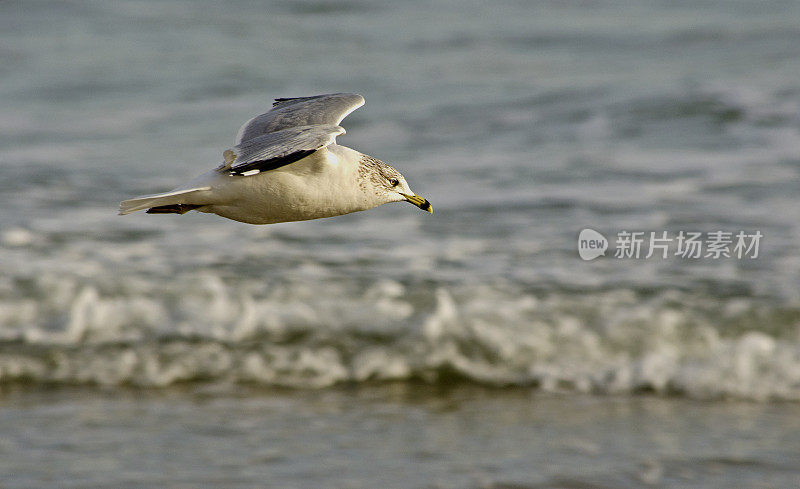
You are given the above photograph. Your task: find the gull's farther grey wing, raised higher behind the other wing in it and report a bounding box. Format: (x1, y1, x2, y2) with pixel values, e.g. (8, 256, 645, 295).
(234, 93, 364, 145)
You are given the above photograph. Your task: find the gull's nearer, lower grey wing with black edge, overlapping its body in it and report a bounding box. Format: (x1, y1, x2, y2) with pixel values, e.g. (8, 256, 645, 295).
(218, 124, 345, 176)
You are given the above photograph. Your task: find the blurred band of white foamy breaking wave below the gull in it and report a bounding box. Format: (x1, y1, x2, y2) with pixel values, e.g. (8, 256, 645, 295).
(0, 274, 800, 400)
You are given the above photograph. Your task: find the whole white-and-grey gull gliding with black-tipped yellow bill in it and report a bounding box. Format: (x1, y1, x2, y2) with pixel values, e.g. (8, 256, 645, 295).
(119, 93, 433, 224)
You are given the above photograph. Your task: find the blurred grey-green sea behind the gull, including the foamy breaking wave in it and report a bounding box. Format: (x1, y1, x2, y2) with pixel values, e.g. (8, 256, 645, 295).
(0, 0, 800, 401)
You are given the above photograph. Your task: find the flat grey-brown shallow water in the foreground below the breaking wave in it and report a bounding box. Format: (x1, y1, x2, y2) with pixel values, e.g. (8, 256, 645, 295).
(0, 383, 800, 489)
